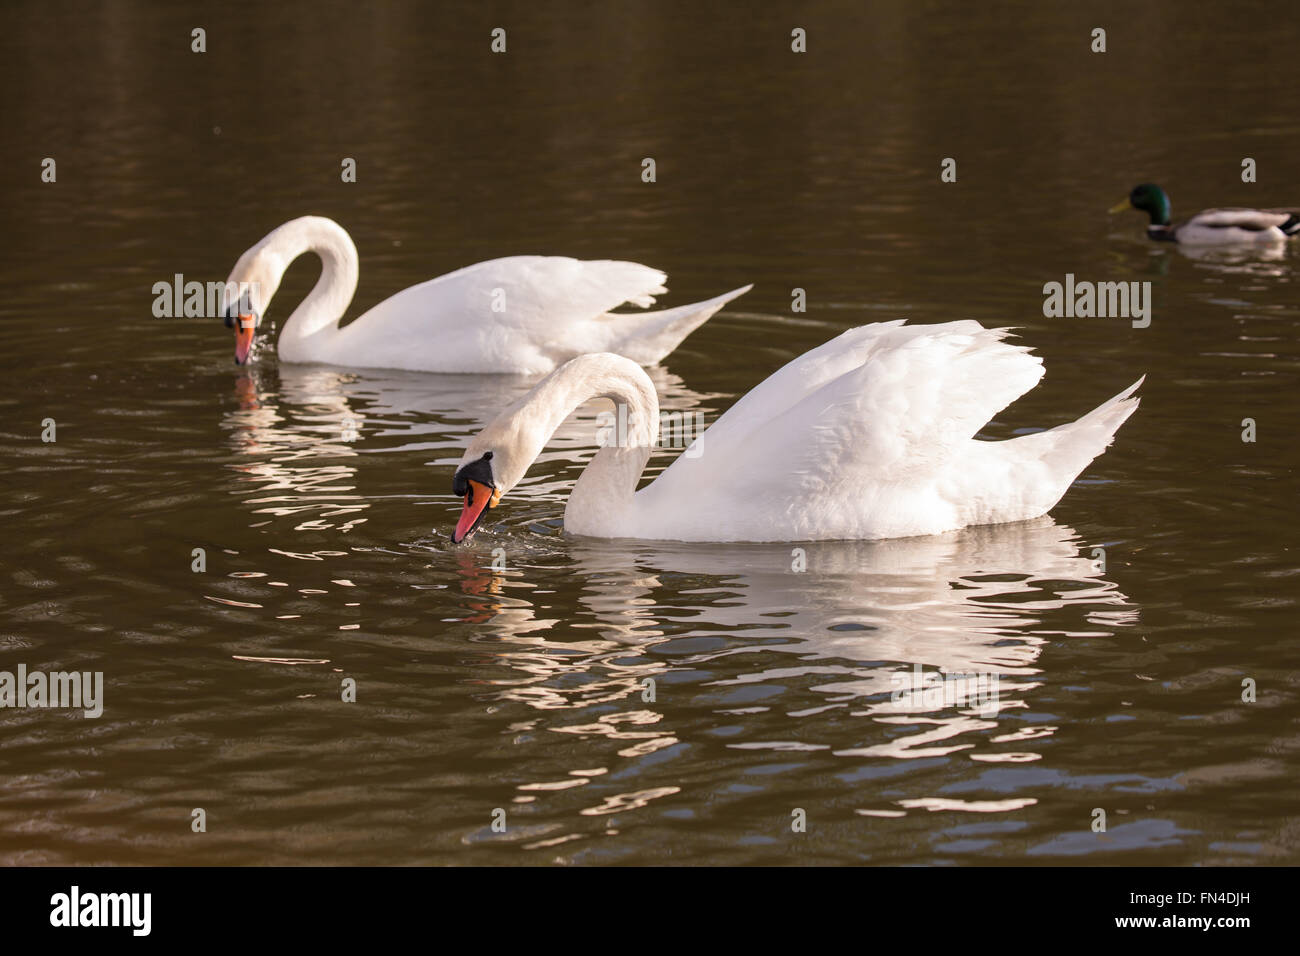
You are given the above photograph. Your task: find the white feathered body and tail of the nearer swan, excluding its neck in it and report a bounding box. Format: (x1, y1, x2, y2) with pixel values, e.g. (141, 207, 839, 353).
(637, 321, 1136, 541)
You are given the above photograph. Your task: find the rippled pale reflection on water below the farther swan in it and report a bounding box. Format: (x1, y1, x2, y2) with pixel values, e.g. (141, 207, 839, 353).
(222, 363, 711, 531)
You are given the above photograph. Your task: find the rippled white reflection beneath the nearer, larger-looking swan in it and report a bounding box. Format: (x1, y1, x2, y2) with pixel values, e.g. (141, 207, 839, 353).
(463, 518, 1136, 762)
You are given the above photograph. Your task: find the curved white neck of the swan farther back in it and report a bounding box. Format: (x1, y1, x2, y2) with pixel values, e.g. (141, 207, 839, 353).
(265, 216, 358, 362)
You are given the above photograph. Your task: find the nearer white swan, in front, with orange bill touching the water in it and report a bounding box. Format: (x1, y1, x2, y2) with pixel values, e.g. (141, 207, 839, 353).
(452, 321, 1141, 541)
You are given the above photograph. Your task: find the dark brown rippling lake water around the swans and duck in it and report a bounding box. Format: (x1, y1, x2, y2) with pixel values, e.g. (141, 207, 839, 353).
(0, 0, 1300, 864)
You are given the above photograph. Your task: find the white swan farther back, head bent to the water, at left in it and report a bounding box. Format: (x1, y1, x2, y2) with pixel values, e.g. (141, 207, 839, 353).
(222, 216, 751, 375)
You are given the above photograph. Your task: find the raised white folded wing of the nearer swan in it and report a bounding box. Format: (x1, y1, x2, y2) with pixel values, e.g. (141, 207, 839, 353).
(640, 321, 1043, 540)
